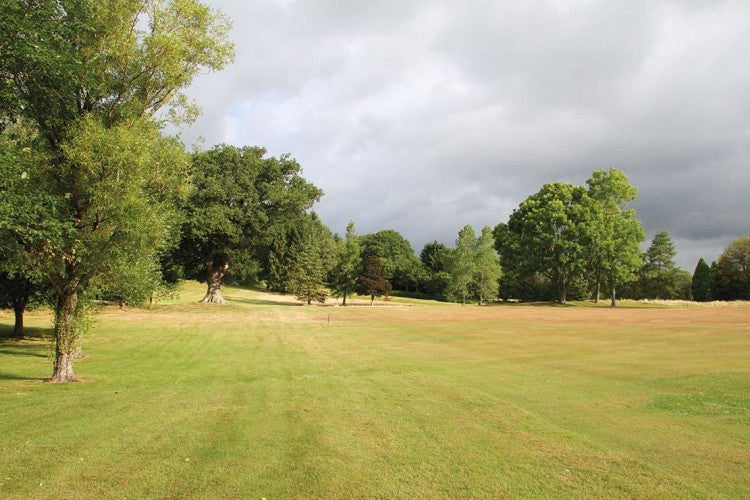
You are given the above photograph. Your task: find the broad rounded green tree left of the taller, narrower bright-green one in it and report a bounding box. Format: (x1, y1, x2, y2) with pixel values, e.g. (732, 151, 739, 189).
(494, 182, 599, 304)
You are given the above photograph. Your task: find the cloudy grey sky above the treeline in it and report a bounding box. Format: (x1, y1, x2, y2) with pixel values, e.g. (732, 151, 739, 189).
(172, 0, 750, 271)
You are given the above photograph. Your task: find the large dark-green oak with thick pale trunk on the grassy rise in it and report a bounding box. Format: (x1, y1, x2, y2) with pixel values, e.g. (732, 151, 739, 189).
(181, 145, 322, 304)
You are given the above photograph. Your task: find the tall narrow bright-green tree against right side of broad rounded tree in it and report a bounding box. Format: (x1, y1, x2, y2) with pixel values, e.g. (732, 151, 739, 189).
(586, 168, 646, 307)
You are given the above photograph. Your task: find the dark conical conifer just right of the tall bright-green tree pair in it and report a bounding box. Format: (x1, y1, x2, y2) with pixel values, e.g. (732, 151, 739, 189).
(640, 231, 680, 299)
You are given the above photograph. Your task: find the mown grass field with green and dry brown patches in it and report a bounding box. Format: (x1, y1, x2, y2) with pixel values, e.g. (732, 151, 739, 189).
(0, 285, 750, 498)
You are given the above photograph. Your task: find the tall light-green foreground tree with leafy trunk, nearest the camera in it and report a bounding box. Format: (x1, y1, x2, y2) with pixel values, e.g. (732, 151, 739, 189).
(0, 0, 233, 382)
